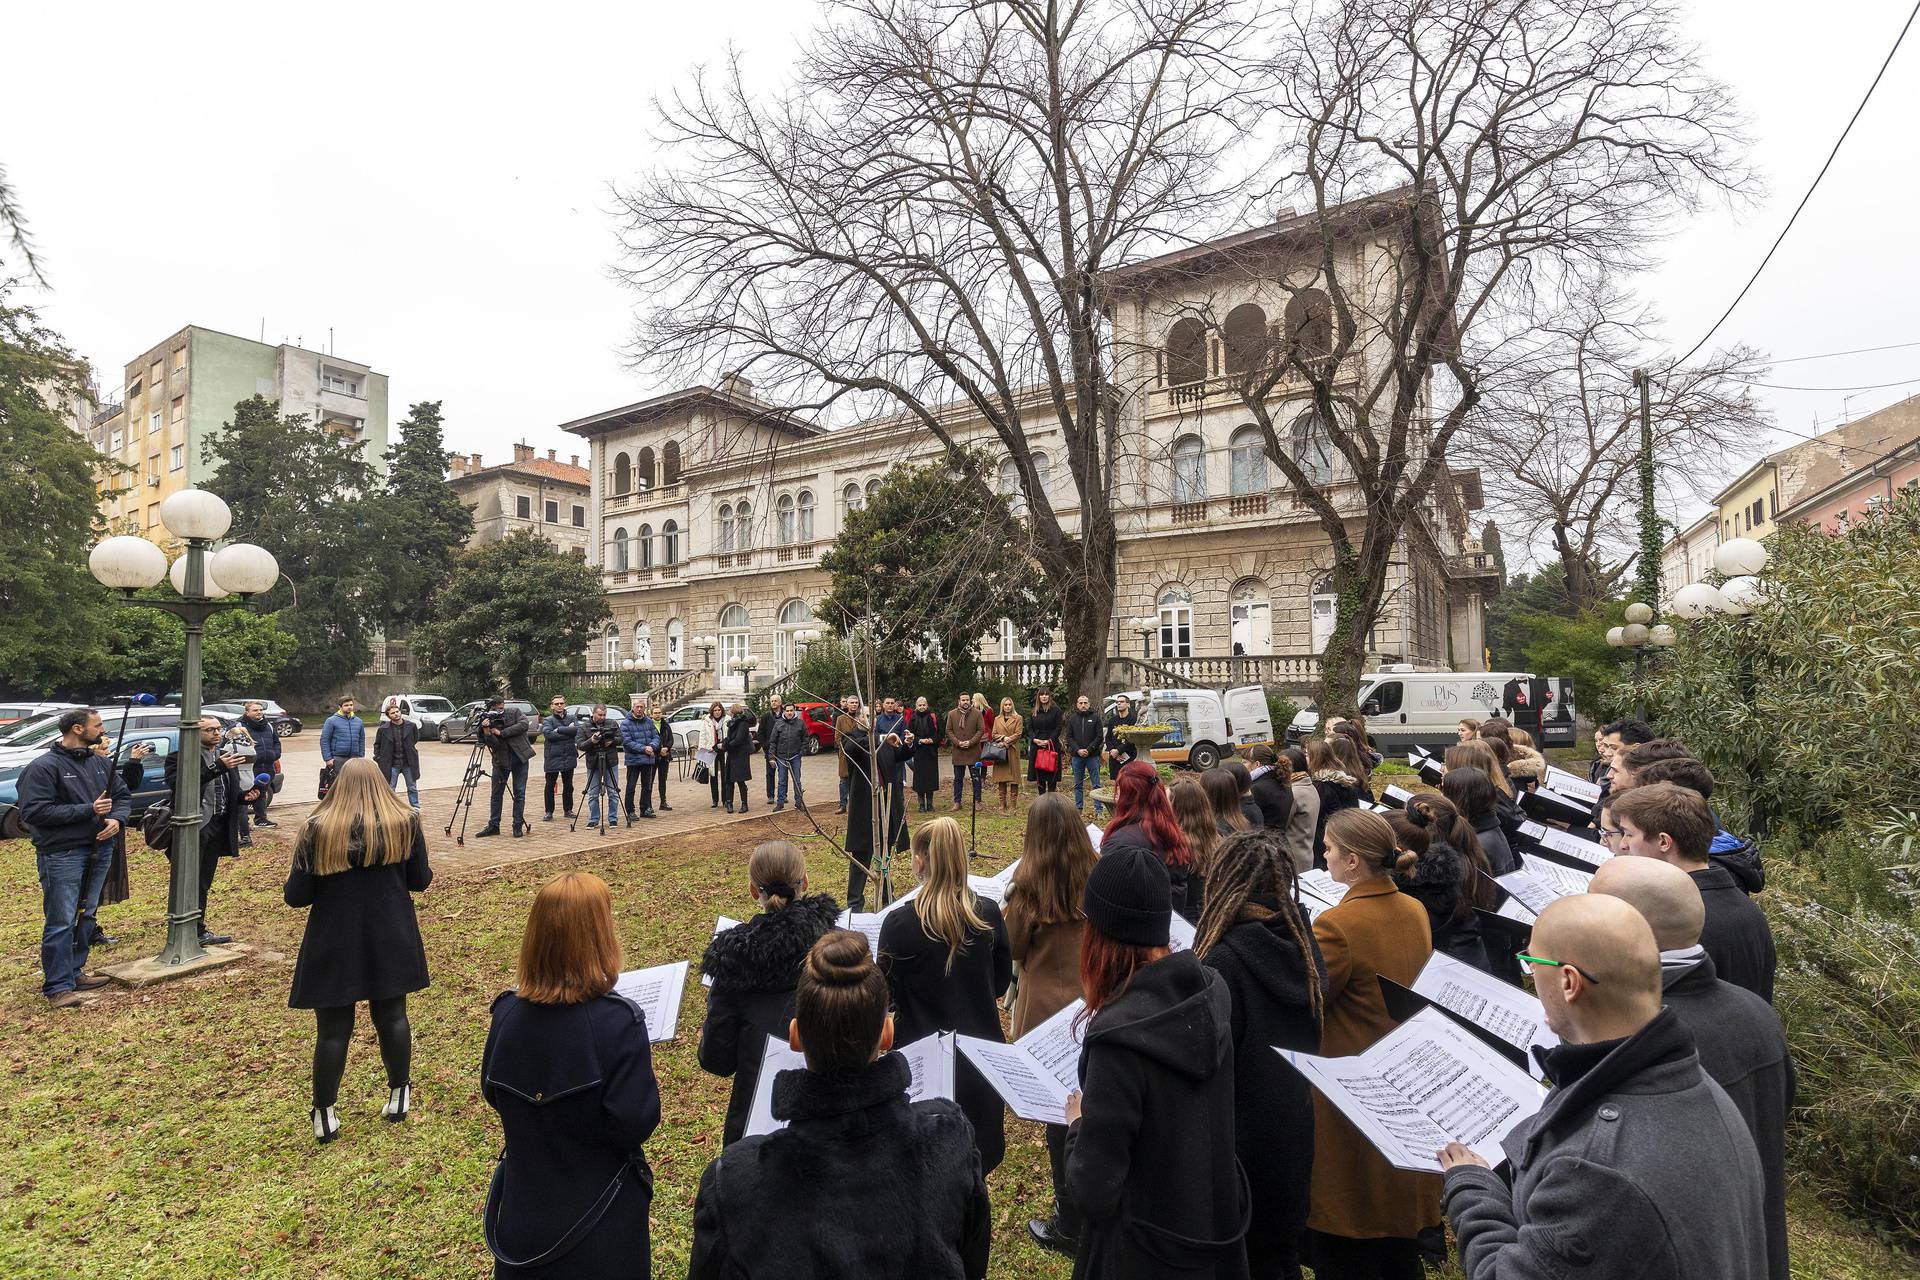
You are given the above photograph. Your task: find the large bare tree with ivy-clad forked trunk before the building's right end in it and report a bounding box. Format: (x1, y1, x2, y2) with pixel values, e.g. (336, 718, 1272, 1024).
(1229, 0, 1743, 706)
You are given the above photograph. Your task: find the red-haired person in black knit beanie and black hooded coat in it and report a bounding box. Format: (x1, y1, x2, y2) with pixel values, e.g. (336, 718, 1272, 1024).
(1066, 844, 1271, 1280)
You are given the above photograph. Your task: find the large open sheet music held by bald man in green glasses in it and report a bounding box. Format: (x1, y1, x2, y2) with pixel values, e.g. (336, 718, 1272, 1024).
(1273, 1009, 1546, 1173)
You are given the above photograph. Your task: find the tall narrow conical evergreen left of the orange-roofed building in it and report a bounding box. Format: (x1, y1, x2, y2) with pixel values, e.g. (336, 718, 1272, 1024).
(384, 399, 474, 631)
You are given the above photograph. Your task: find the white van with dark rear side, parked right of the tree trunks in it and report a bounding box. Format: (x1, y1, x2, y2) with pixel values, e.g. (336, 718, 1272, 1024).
(1286, 666, 1574, 756)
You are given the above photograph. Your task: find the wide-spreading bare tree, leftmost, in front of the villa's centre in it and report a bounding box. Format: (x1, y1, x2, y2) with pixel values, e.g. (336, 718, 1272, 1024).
(606, 0, 1246, 693)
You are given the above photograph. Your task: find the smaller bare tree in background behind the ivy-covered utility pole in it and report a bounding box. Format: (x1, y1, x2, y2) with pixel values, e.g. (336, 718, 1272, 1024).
(1453, 288, 1764, 608)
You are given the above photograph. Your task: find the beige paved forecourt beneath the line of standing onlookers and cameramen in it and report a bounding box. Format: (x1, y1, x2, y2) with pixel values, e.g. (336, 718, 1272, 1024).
(271, 752, 845, 875)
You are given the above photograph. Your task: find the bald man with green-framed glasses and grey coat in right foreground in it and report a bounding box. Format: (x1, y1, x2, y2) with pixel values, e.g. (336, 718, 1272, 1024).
(1438, 894, 1766, 1280)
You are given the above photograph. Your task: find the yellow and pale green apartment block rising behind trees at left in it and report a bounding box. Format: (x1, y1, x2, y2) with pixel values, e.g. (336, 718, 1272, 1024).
(90, 324, 388, 537)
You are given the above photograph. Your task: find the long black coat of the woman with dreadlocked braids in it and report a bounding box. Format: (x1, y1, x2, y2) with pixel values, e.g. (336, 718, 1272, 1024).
(1202, 900, 1327, 1276)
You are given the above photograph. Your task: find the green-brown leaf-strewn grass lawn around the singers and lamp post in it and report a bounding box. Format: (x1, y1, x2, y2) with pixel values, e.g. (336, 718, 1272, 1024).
(0, 794, 1920, 1280)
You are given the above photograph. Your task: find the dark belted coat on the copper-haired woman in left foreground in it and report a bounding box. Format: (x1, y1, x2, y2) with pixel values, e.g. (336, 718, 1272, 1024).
(480, 992, 660, 1280)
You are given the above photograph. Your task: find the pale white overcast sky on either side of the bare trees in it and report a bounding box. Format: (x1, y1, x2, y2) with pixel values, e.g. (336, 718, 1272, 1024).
(0, 0, 1920, 541)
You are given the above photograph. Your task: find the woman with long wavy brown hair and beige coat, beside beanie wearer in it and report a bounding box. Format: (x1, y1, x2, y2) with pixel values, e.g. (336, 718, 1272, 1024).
(1004, 793, 1098, 1257)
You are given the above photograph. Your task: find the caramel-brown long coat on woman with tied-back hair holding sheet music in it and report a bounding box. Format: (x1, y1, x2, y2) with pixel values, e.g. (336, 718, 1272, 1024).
(1308, 875, 1440, 1240)
